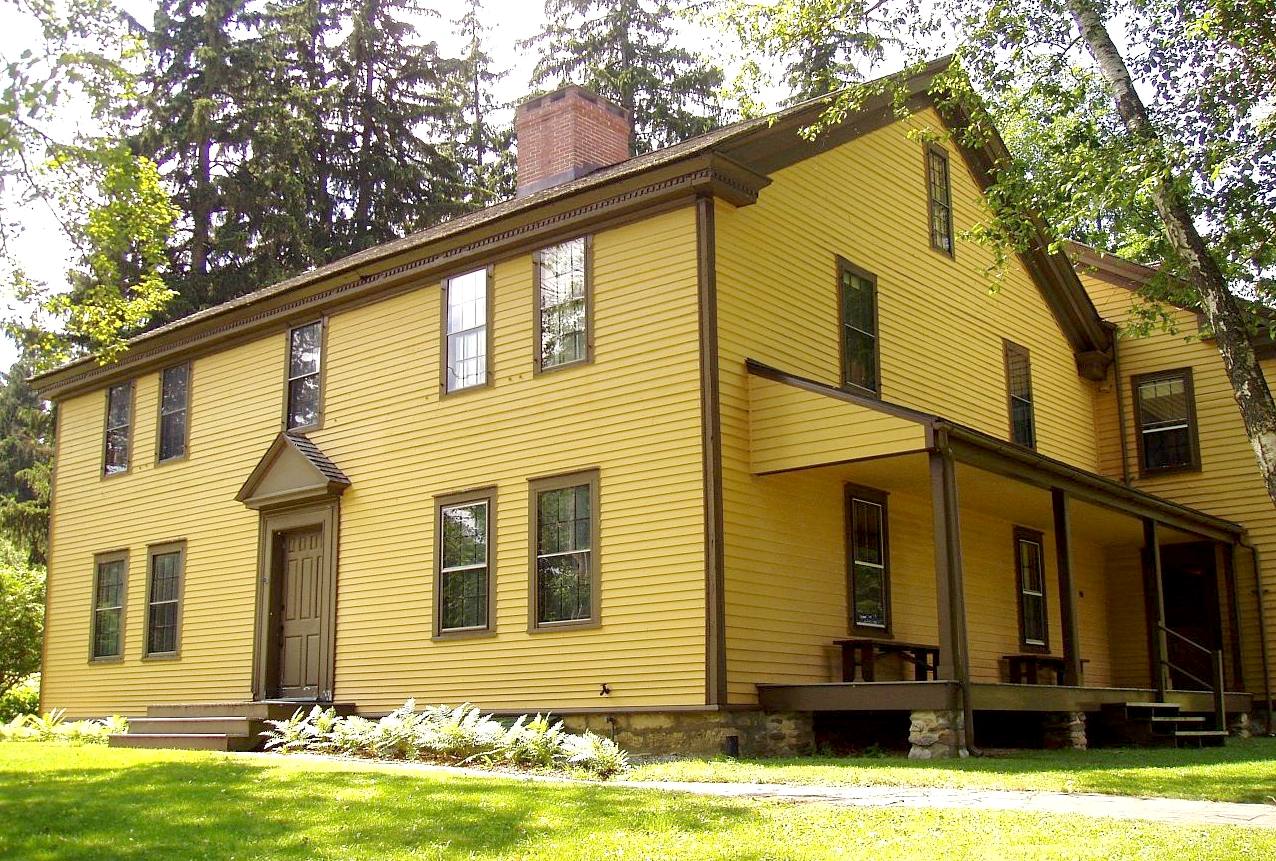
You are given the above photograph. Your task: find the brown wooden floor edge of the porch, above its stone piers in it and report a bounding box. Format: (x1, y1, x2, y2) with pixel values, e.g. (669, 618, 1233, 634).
(758, 681, 1253, 713)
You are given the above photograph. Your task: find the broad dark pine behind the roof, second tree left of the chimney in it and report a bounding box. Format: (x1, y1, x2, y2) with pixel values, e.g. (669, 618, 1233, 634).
(332, 0, 464, 253)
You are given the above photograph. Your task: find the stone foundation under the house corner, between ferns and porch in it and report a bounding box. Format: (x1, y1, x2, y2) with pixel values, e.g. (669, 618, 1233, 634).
(563, 709, 815, 756)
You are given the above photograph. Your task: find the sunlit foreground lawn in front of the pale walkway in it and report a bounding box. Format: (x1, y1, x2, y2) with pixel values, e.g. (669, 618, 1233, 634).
(0, 742, 1276, 861)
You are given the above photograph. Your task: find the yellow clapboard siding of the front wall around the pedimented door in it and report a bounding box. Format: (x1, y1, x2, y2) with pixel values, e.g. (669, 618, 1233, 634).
(46, 208, 704, 713)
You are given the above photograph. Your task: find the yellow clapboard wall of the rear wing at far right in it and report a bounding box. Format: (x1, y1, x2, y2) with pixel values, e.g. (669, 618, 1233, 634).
(1081, 270, 1276, 691)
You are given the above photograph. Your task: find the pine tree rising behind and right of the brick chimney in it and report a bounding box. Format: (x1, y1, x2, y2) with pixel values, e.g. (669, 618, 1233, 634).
(523, 0, 723, 153)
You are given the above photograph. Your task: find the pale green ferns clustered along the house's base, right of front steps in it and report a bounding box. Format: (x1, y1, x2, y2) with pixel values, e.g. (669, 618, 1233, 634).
(262, 699, 629, 777)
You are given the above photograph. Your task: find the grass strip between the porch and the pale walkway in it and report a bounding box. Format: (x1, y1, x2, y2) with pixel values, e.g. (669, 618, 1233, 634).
(630, 739, 1276, 802)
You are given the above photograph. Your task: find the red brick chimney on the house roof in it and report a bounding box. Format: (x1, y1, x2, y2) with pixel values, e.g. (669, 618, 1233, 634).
(514, 84, 630, 198)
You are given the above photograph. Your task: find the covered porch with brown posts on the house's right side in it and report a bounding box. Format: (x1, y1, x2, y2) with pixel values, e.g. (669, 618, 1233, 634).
(749, 362, 1250, 751)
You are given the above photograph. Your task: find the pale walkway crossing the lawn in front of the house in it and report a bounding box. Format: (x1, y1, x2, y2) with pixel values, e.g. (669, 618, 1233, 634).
(266, 754, 1276, 829)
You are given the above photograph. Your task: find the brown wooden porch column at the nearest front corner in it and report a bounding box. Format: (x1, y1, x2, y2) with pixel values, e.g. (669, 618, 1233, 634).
(930, 445, 970, 688)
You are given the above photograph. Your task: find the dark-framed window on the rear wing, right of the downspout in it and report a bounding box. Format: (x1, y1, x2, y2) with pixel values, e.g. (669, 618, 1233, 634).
(1131, 367, 1201, 475)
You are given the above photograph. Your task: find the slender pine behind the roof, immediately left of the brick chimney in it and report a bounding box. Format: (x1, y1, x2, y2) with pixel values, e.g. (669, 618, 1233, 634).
(453, 0, 514, 208)
